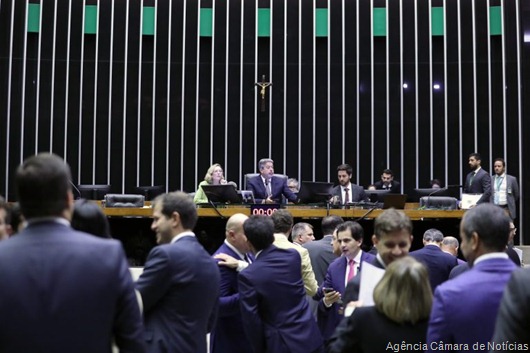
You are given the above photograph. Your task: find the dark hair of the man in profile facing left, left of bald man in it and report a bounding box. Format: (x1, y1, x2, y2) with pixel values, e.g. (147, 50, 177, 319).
(153, 191, 199, 229)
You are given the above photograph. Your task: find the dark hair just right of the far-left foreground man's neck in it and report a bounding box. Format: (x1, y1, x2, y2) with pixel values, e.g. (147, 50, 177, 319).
(70, 199, 111, 238)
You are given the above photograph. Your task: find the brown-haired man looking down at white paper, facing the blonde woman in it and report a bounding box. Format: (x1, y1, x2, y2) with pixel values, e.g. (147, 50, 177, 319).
(342, 208, 412, 306)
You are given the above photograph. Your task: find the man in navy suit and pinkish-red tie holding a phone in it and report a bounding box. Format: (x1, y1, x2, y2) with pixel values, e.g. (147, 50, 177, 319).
(315, 221, 375, 341)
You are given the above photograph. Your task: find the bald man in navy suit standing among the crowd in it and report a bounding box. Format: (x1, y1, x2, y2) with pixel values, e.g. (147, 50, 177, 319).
(210, 213, 250, 353)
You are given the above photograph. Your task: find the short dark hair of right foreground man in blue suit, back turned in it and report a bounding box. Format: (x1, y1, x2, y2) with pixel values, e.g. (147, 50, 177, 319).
(462, 203, 510, 252)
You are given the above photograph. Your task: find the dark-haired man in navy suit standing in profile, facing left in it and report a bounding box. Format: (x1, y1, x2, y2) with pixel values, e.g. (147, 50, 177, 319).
(136, 192, 219, 353)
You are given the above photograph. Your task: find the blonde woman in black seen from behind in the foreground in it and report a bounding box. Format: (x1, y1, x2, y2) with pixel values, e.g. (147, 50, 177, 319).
(329, 256, 432, 353)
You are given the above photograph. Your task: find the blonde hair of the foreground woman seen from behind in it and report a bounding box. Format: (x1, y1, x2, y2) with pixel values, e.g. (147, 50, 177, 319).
(374, 256, 432, 324)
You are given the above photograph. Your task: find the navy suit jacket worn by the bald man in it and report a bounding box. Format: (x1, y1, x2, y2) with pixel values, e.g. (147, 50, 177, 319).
(210, 243, 250, 353)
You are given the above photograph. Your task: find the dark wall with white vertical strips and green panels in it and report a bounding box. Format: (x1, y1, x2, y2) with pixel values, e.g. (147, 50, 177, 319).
(0, 0, 530, 239)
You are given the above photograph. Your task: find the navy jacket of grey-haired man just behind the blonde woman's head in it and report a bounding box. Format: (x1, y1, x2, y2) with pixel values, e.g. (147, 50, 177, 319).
(409, 245, 458, 292)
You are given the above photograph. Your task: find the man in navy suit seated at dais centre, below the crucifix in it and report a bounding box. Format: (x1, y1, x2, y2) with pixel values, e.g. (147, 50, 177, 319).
(247, 158, 298, 203)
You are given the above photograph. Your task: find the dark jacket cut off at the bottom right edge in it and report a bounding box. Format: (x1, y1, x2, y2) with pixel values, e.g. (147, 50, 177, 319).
(491, 269, 530, 346)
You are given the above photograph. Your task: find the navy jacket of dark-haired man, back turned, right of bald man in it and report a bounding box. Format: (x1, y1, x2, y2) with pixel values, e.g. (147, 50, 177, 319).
(239, 245, 322, 353)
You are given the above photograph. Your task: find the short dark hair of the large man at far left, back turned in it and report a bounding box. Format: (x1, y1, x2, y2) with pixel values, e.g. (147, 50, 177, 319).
(15, 153, 71, 219)
